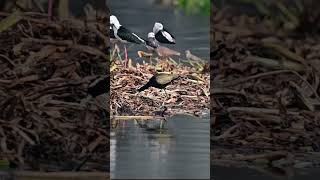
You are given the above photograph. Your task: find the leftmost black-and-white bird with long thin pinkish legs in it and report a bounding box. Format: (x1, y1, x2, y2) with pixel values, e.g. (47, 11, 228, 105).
(110, 15, 145, 66)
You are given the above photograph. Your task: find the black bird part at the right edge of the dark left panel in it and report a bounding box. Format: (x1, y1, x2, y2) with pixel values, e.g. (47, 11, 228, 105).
(88, 76, 110, 98)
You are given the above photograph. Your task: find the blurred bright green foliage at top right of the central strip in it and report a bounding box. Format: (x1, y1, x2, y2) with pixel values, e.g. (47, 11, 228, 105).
(178, 0, 210, 16)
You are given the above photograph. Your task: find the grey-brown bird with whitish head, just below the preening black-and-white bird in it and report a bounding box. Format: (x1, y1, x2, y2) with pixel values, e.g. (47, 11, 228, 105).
(146, 32, 180, 57)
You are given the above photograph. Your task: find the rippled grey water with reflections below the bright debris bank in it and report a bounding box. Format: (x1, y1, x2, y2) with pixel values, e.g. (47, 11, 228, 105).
(110, 115, 210, 179)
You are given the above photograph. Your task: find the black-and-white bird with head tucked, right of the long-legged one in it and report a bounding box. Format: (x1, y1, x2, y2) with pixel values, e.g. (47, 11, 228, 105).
(152, 22, 176, 44)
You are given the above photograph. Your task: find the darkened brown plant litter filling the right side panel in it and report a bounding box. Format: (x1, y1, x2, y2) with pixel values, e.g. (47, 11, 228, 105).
(210, 1, 320, 168)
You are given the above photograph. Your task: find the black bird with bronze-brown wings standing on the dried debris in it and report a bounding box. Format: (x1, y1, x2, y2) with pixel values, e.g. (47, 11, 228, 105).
(138, 74, 179, 92)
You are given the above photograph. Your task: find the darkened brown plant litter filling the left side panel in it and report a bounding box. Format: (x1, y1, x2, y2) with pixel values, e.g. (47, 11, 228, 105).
(0, 12, 109, 171)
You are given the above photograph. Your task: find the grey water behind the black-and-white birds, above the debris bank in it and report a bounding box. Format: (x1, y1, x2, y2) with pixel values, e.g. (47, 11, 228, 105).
(108, 0, 210, 60)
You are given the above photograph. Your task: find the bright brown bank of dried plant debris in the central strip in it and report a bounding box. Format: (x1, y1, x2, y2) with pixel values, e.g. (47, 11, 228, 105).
(110, 57, 210, 123)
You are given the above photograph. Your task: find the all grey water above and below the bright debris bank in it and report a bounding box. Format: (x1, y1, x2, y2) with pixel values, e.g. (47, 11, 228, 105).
(108, 0, 210, 179)
